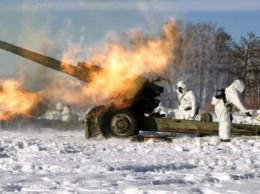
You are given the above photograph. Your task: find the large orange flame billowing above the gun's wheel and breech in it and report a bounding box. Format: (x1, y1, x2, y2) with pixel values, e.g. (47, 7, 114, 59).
(56, 21, 179, 108)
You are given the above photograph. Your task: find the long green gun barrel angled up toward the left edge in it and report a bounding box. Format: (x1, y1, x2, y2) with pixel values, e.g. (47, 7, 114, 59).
(0, 40, 88, 81)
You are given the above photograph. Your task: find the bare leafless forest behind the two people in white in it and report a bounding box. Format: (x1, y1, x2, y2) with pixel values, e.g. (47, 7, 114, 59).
(153, 22, 260, 110)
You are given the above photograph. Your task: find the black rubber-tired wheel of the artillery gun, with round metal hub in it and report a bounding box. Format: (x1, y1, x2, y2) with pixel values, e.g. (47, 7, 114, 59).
(100, 110, 139, 138)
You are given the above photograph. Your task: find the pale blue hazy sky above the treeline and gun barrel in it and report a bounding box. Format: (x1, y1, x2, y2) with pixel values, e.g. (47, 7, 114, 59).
(0, 0, 260, 76)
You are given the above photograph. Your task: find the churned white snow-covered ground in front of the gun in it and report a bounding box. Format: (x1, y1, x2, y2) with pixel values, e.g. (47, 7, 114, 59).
(0, 125, 260, 194)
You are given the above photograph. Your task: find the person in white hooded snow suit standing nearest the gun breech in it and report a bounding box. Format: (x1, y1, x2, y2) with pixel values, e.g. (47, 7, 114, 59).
(177, 79, 198, 120)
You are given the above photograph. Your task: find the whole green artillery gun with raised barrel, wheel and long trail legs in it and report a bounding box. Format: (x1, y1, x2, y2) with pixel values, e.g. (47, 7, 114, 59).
(0, 41, 260, 138)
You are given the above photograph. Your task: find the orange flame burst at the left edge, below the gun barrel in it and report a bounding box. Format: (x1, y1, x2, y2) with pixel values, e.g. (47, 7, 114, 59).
(0, 80, 46, 120)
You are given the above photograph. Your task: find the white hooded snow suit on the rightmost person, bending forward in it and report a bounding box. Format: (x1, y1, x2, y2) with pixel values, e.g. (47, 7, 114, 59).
(211, 80, 249, 140)
